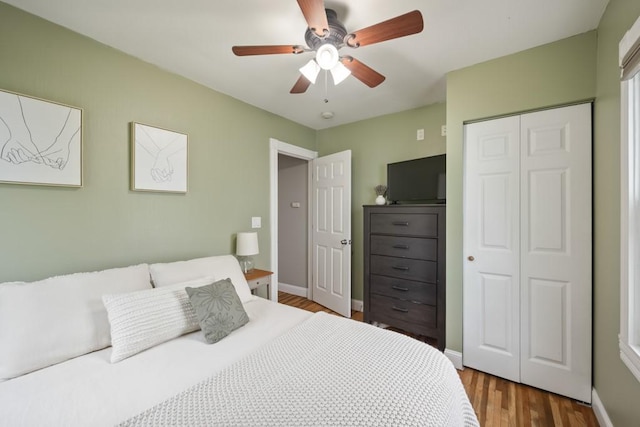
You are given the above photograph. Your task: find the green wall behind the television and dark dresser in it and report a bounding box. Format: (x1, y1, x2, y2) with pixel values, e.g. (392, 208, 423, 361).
(317, 104, 446, 300)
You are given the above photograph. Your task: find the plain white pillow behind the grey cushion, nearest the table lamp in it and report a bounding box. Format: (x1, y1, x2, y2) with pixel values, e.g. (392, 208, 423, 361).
(149, 255, 252, 303)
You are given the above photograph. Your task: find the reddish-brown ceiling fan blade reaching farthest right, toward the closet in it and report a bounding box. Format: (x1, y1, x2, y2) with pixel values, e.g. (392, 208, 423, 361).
(345, 10, 424, 47)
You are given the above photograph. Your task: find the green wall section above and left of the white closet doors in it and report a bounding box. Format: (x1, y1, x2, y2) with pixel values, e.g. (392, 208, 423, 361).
(447, 31, 597, 351)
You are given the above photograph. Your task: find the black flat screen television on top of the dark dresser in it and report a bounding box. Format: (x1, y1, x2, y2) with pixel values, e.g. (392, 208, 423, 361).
(387, 154, 447, 204)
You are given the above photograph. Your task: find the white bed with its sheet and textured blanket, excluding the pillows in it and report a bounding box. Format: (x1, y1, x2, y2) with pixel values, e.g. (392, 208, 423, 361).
(0, 256, 478, 427)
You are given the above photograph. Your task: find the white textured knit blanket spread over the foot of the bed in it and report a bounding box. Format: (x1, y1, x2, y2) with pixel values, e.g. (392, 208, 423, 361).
(122, 313, 479, 427)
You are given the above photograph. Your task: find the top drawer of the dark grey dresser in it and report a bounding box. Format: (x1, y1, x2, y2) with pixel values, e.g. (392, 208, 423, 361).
(370, 213, 438, 237)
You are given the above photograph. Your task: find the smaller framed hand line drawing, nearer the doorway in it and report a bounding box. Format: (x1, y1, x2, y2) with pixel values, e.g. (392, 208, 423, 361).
(131, 122, 188, 193)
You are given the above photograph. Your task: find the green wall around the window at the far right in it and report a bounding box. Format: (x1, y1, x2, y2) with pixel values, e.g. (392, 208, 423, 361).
(593, 0, 640, 426)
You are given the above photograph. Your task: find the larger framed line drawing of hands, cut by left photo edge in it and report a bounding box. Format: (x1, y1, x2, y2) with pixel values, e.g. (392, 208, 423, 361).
(0, 89, 82, 187)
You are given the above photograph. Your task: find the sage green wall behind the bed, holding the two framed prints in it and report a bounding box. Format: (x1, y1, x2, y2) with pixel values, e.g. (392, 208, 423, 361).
(0, 3, 315, 282)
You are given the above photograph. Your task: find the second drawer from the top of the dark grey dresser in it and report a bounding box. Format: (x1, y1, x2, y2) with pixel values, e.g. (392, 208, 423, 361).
(371, 235, 438, 261)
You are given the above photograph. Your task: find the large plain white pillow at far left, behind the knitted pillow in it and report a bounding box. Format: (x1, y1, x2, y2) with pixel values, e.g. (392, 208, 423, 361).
(0, 264, 151, 381)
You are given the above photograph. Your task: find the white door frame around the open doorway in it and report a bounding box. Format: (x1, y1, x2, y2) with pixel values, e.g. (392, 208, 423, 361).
(269, 138, 318, 302)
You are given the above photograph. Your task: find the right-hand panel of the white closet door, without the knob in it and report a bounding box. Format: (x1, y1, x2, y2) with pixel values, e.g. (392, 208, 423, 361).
(520, 104, 592, 402)
